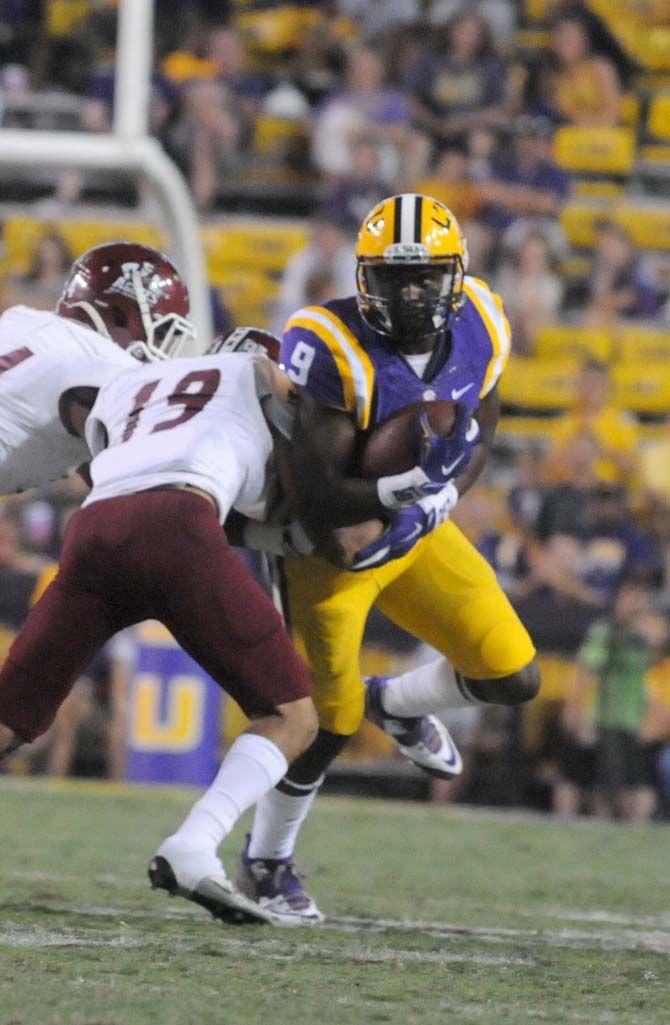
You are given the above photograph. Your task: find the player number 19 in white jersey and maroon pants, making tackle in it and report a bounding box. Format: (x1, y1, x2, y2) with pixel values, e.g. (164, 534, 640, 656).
(0, 354, 317, 920)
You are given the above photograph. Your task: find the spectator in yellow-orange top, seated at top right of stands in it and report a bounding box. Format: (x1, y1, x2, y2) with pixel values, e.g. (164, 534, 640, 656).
(532, 14, 621, 126)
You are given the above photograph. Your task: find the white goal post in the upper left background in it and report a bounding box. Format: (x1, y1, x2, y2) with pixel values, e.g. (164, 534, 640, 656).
(0, 0, 212, 350)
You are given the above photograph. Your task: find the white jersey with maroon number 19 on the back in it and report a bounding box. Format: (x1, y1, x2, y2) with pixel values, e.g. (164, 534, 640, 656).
(84, 353, 273, 523)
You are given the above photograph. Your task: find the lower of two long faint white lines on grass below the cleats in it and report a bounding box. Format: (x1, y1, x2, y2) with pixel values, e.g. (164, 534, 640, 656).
(0, 925, 536, 968)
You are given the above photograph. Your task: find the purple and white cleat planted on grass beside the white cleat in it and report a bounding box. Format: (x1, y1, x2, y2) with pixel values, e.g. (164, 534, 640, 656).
(236, 835, 324, 926)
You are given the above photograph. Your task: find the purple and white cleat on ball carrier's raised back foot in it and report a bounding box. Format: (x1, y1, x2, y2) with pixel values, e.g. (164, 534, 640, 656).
(365, 677, 463, 779)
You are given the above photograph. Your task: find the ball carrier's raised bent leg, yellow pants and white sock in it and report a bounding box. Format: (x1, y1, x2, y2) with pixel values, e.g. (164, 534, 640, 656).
(377, 523, 540, 715)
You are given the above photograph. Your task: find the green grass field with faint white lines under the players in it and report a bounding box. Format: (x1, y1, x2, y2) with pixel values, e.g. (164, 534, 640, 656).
(0, 779, 670, 1025)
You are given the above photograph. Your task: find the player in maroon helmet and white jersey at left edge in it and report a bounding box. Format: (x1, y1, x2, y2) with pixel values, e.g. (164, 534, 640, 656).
(0, 242, 194, 494)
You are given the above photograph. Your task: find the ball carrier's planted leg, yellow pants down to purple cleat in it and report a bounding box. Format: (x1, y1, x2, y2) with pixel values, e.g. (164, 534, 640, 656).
(237, 559, 378, 923)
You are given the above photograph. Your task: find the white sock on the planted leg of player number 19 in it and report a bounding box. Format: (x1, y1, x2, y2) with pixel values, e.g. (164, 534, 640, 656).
(172, 733, 288, 853)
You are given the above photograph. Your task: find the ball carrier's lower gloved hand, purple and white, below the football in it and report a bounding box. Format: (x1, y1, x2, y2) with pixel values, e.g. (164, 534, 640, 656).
(349, 482, 458, 573)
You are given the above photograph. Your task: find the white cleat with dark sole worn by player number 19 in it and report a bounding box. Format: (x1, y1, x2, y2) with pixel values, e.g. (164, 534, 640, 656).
(149, 836, 277, 925)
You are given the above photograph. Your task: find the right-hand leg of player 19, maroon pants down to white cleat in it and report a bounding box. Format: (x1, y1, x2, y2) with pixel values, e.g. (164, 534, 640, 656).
(150, 492, 317, 920)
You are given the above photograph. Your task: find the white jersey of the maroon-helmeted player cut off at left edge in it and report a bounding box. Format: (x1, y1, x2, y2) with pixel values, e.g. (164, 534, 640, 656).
(0, 306, 137, 495)
